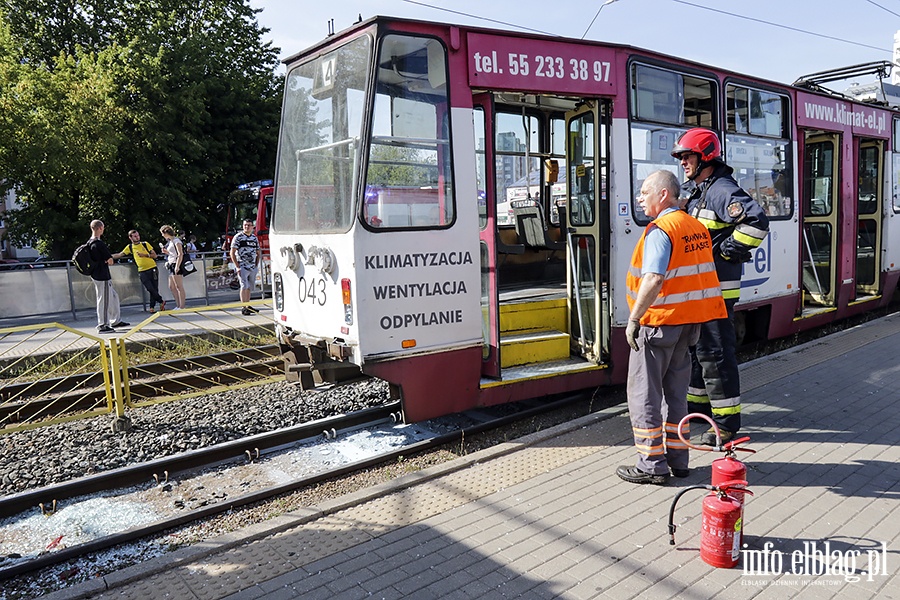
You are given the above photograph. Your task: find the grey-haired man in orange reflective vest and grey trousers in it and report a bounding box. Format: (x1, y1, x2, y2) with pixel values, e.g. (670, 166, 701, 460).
(616, 171, 727, 485)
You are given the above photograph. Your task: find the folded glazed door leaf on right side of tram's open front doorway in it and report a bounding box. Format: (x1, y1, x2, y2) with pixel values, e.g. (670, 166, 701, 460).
(566, 100, 609, 363)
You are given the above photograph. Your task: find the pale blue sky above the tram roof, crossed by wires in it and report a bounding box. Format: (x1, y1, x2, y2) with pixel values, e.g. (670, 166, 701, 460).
(250, 0, 900, 83)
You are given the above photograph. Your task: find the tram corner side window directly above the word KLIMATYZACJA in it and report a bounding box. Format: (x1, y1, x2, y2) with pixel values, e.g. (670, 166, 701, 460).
(362, 35, 454, 229)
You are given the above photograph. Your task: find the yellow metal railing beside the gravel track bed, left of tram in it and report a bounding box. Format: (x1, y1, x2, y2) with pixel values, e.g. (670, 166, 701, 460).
(0, 300, 281, 434)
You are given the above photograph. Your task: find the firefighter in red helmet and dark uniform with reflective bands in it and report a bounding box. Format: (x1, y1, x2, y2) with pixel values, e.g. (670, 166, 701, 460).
(672, 127, 769, 446)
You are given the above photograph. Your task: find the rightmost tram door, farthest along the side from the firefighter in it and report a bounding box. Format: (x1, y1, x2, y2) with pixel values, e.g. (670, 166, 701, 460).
(856, 140, 884, 300)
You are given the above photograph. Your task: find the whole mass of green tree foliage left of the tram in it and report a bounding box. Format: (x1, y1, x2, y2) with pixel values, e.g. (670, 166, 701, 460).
(0, 0, 280, 258)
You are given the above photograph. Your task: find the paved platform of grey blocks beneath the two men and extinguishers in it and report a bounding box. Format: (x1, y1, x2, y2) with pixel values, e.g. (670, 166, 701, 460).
(46, 316, 900, 600)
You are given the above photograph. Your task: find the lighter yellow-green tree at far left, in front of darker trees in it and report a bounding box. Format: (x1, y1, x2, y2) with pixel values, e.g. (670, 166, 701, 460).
(0, 15, 124, 257)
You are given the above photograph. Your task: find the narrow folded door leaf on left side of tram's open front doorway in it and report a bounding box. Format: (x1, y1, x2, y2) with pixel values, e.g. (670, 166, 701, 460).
(472, 94, 500, 379)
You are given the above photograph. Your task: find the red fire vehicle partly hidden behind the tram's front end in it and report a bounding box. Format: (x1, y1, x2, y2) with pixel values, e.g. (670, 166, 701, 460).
(222, 179, 274, 288)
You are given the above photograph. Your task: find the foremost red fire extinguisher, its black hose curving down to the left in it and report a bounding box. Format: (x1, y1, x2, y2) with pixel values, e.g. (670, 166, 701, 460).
(669, 480, 753, 569)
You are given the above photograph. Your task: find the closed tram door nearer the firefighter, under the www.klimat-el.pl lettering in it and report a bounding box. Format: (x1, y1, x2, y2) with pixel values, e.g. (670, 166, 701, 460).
(801, 134, 841, 307)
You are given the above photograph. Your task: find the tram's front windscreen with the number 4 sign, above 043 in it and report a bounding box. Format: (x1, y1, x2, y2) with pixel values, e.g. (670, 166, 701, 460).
(272, 35, 372, 233)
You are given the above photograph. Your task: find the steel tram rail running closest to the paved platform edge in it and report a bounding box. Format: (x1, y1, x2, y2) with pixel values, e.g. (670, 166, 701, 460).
(0, 392, 604, 581)
